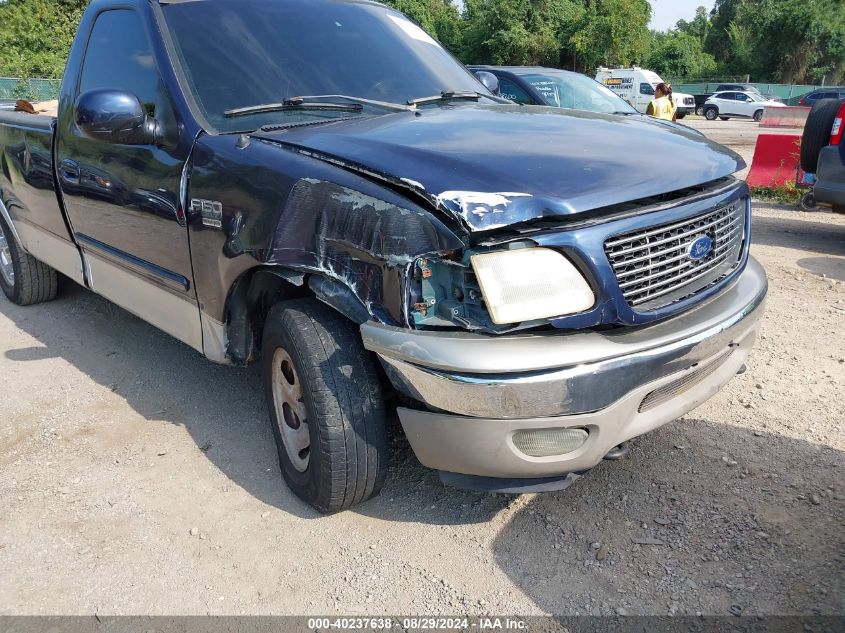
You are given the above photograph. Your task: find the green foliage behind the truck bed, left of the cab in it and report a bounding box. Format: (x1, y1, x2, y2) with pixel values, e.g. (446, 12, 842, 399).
(0, 0, 88, 78)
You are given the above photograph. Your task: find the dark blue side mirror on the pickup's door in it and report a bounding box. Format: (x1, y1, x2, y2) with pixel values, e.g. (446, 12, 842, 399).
(73, 90, 160, 145)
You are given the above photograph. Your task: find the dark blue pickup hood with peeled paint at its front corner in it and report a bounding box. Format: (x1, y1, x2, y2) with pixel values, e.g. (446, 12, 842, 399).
(253, 103, 745, 231)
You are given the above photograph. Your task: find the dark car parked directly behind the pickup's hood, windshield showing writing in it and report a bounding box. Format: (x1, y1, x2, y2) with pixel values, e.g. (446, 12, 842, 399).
(468, 66, 638, 114)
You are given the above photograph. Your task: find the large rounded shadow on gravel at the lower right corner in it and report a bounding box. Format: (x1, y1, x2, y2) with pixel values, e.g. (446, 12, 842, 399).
(484, 419, 845, 615)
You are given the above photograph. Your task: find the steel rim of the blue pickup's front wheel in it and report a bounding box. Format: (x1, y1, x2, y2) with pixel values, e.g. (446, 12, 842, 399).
(272, 347, 311, 473)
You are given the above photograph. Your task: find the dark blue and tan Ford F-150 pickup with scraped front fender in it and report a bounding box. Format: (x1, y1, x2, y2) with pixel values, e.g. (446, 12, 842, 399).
(0, 0, 767, 511)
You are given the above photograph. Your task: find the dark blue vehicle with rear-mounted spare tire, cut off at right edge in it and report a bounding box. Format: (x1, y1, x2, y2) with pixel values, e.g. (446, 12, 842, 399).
(801, 98, 845, 212)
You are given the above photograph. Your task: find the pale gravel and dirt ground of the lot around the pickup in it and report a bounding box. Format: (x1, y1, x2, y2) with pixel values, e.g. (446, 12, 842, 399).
(0, 122, 845, 615)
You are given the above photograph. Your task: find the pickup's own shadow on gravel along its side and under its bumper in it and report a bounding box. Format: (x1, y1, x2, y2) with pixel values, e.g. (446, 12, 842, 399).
(0, 279, 506, 523)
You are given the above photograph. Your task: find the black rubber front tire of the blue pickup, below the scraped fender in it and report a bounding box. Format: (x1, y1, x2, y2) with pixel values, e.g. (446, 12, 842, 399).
(261, 299, 388, 512)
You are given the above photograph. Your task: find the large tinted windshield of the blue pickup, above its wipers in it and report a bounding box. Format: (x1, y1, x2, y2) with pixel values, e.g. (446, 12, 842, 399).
(161, 0, 492, 132)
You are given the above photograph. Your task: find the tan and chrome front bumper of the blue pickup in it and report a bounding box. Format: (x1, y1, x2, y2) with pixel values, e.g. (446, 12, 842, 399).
(362, 254, 767, 478)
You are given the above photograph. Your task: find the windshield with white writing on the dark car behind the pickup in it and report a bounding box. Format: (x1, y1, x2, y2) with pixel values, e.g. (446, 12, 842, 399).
(522, 72, 636, 114)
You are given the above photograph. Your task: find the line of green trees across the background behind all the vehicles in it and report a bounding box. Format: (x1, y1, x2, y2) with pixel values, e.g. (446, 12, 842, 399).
(0, 0, 845, 85)
